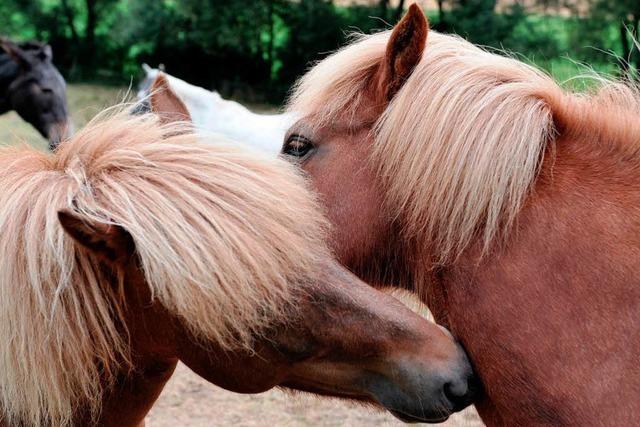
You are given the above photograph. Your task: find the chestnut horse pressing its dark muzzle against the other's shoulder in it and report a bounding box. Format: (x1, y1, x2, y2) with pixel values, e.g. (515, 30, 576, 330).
(0, 77, 473, 427)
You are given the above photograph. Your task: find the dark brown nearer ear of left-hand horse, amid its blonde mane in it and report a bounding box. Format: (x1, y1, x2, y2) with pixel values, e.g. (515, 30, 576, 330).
(58, 209, 135, 263)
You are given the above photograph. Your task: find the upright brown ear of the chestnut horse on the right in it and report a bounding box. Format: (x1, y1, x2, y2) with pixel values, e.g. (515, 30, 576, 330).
(378, 3, 429, 101)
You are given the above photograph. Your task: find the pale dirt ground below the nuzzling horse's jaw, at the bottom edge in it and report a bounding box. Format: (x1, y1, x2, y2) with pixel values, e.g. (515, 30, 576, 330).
(146, 364, 483, 427)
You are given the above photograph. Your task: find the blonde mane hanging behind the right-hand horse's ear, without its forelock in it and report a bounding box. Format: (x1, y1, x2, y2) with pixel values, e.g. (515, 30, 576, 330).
(374, 32, 563, 263)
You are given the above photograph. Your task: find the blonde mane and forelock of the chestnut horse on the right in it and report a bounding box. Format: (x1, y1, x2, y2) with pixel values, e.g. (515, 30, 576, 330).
(288, 31, 640, 263)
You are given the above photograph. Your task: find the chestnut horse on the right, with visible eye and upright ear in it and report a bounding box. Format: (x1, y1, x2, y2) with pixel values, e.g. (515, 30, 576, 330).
(283, 5, 640, 426)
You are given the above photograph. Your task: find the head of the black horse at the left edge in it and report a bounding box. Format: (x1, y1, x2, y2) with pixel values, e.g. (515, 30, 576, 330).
(0, 39, 71, 149)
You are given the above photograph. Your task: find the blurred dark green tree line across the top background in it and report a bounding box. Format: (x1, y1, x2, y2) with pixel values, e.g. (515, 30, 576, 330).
(0, 0, 640, 102)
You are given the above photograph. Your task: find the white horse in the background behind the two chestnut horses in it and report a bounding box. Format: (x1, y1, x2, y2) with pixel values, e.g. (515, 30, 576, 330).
(137, 64, 295, 155)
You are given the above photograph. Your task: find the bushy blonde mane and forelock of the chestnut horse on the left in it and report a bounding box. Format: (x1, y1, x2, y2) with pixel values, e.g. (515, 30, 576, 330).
(0, 113, 326, 426)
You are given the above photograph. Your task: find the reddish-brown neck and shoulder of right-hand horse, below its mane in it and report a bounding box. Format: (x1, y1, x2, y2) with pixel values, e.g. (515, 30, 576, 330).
(429, 135, 640, 425)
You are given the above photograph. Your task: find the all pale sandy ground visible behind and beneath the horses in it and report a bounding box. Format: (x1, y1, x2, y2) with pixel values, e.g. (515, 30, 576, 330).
(0, 85, 483, 427)
